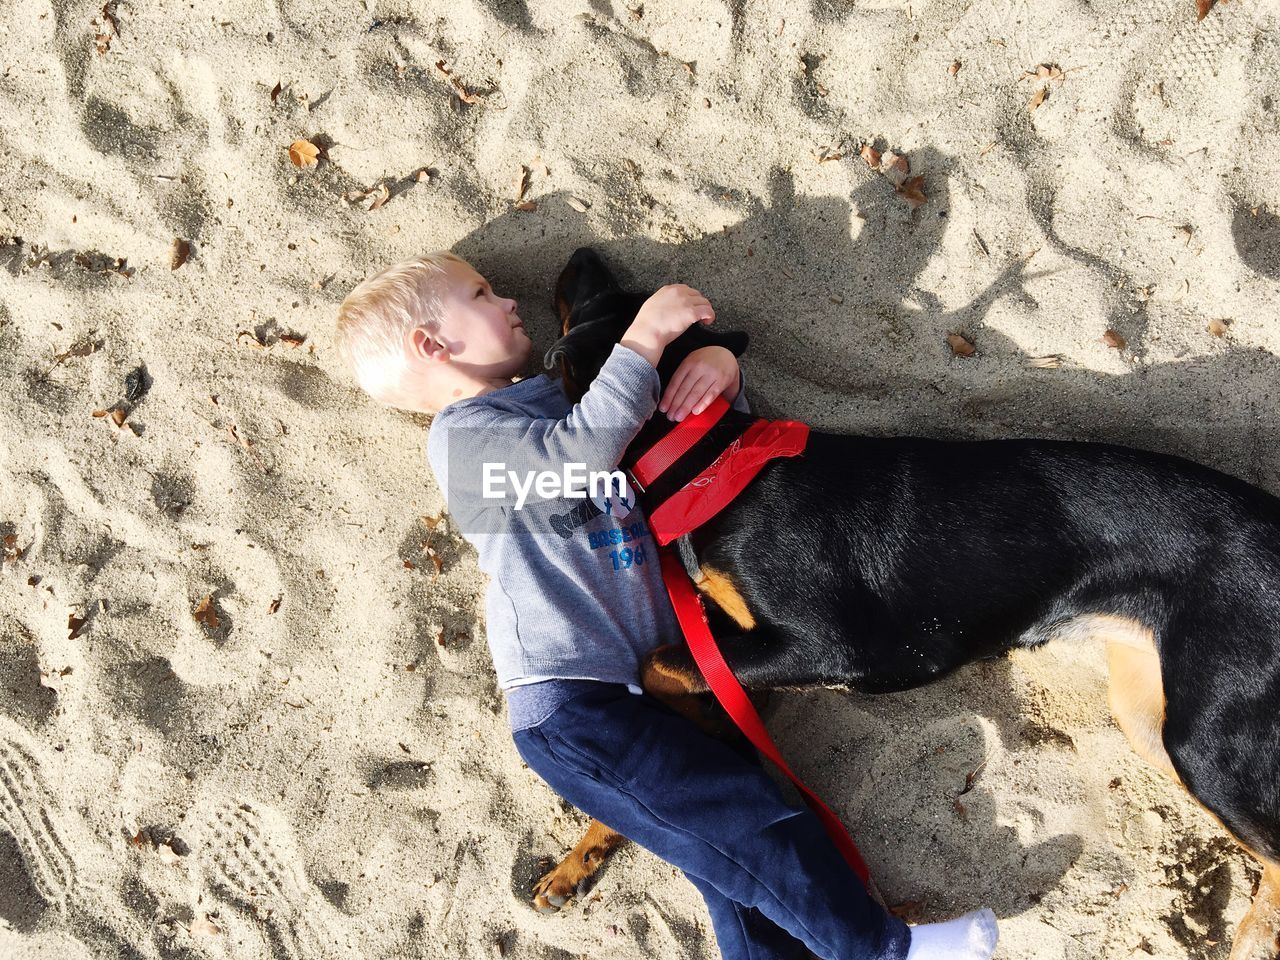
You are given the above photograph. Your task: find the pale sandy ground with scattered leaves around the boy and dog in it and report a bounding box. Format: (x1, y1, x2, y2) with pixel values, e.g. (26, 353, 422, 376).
(0, 0, 1280, 960)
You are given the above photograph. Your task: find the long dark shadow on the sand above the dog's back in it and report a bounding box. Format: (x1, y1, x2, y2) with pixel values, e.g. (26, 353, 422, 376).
(453, 156, 1280, 492)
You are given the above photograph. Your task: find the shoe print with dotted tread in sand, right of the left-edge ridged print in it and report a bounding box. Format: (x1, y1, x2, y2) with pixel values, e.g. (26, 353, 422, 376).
(193, 799, 333, 960)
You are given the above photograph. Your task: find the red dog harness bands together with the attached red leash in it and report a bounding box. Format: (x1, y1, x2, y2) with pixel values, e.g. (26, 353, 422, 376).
(631, 397, 870, 886)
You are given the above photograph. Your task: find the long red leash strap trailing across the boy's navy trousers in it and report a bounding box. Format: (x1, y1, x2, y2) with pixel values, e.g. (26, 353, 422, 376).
(659, 547, 870, 888)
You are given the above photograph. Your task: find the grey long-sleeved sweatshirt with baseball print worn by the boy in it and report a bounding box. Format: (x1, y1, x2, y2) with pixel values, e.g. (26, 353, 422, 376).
(426, 344, 746, 728)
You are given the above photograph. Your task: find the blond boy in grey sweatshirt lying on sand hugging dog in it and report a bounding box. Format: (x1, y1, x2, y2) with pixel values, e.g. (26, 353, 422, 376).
(338, 252, 997, 960)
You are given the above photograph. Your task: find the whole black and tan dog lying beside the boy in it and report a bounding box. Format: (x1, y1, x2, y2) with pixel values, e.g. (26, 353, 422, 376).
(529, 248, 1280, 959)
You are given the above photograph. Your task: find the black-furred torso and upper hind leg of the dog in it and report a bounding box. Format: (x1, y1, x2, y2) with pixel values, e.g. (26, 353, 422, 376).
(695, 434, 1280, 860)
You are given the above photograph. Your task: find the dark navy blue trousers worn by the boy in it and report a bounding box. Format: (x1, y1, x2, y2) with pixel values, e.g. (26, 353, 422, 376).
(513, 684, 911, 960)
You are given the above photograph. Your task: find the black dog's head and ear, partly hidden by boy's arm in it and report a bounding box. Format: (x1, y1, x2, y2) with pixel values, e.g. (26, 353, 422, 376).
(544, 247, 748, 402)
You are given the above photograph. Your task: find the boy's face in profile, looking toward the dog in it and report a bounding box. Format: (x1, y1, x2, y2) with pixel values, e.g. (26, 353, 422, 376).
(436, 262, 532, 379)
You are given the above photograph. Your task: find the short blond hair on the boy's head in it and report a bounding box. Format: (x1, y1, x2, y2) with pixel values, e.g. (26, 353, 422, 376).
(337, 250, 467, 401)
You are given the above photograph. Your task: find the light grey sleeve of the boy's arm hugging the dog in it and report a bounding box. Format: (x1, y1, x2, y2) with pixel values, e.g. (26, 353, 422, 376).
(428, 344, 659, 511)
